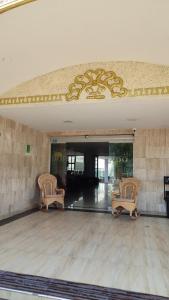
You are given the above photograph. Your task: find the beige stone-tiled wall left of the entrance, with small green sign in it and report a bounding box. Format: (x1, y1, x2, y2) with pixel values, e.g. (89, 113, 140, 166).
(0, 117, 50, 219)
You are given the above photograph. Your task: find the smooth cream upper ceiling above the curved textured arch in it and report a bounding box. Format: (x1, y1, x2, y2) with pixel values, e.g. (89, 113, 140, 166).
(0, 0, 169, 94)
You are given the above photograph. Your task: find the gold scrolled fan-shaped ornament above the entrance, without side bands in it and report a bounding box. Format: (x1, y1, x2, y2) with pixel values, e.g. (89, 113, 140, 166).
(66, 69, 127, 101)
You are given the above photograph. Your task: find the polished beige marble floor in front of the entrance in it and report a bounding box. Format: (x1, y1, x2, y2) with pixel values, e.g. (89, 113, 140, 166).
(0, 210, 169, 297)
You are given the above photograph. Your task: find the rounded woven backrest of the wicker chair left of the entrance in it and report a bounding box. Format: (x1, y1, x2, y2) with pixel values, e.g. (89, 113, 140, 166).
(38, 173, 57, 196)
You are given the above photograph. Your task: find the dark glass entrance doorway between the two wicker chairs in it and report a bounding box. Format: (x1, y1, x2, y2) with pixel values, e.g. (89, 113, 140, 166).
(51, 142, 133, 211)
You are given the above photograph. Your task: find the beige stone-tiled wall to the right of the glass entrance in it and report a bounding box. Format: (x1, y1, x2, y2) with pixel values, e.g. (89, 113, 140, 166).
(134, 129, 169, 214)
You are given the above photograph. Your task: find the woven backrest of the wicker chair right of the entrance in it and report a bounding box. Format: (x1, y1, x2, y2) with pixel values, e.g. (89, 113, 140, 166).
(119, 178, 139, 202)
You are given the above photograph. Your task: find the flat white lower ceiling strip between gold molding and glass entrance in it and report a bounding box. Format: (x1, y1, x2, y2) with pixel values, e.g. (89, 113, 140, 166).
(0, 96, 169, 132)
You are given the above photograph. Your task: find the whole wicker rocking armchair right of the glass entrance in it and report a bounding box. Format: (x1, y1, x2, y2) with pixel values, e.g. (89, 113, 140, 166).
(112, 178, 139, 219)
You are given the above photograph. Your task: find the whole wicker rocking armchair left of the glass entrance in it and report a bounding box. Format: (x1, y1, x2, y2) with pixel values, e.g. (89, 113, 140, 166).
(38, 173, 65, 210)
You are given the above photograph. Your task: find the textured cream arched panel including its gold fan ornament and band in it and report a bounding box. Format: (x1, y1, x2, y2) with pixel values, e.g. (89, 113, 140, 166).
(0, 61, 169, 105)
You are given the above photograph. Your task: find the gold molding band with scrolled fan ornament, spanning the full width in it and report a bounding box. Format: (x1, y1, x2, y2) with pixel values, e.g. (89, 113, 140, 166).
(0, 69, 169, 105)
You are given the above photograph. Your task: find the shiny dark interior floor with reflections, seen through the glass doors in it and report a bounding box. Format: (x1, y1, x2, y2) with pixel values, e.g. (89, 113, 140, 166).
(65, 182, 114, 211)
